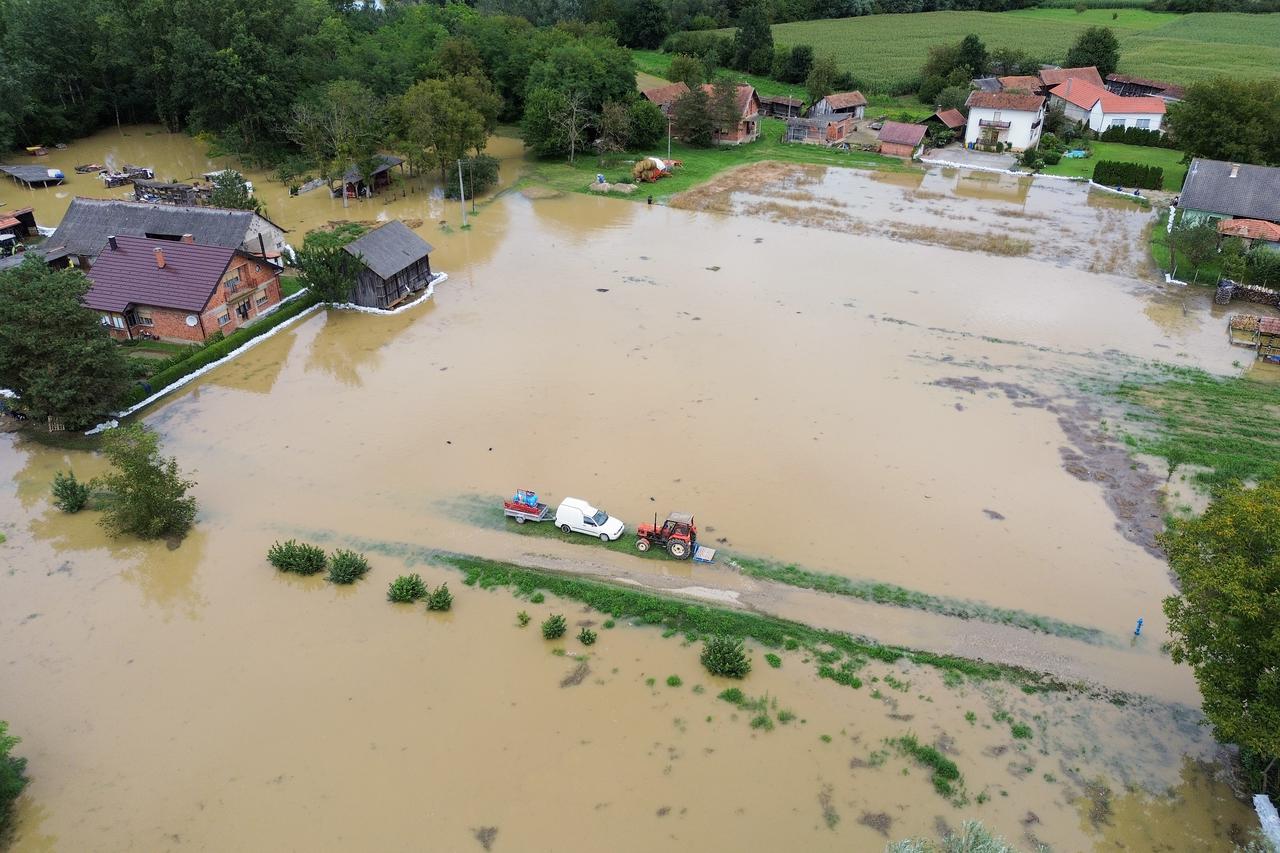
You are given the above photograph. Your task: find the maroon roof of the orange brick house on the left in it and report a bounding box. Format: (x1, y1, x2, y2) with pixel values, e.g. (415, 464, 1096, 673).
(84, 237, 236, 314)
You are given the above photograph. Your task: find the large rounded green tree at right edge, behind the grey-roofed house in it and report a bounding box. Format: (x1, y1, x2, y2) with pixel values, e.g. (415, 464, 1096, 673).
(1169, 77, 1280, 165)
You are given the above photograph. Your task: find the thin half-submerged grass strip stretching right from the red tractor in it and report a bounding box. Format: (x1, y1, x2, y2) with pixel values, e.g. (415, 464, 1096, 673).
(732, 556, 1110, 646)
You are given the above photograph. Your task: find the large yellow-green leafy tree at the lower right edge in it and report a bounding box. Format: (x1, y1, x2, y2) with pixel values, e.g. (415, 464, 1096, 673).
(1160, 479, 1280, 794)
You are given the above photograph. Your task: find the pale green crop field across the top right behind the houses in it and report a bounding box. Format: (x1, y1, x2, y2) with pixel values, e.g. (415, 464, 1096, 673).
(726, 9, 1280, 91)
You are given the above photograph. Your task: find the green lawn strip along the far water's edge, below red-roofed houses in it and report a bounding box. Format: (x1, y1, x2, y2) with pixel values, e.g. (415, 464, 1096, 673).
(527, 119, 919, 201)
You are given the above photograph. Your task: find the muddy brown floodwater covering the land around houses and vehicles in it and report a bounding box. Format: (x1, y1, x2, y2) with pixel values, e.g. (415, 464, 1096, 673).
(0, 128, 1252, 852)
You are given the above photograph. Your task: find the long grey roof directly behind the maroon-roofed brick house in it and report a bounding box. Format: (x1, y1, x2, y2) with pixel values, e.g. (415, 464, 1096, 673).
(45, 199, 282, 257)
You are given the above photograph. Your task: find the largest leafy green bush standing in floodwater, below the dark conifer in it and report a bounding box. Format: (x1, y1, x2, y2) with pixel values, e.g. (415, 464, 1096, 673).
(95, 423, 196, 539)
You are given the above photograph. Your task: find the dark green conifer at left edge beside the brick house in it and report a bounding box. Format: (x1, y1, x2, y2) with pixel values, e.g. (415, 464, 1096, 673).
(0, 257, 129, 429)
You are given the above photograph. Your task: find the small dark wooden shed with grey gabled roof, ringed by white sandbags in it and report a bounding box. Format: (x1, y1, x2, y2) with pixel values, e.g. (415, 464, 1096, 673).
(346, 219, 435, 310)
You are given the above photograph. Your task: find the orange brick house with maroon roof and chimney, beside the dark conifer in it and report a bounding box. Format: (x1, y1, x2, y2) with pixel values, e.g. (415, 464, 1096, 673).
(84, 236, 280, 343)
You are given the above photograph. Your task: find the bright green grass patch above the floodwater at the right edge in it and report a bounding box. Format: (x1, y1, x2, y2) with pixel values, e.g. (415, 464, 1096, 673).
(1114, 365, 1280, 487)
